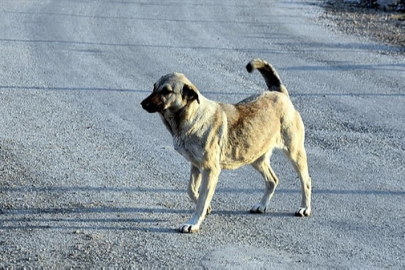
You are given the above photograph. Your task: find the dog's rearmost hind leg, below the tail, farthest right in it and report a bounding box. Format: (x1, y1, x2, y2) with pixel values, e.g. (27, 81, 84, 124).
(284, 143, 311, 217)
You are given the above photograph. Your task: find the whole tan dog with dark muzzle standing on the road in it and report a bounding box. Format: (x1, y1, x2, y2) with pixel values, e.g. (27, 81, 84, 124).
(141, 59, 311, 233)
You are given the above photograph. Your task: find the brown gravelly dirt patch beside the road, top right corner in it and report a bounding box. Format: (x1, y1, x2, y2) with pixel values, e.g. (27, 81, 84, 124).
(321, 0, 405, 53)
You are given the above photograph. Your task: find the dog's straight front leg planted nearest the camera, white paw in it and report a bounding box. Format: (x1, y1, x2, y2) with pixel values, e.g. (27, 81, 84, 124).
(180, 168, 221, 233)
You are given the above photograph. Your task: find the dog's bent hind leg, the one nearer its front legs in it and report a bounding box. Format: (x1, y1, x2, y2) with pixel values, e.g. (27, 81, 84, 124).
(250, 151, 278, 214)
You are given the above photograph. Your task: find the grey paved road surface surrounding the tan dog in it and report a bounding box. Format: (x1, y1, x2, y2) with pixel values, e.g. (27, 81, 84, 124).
(0, 0, 405, 269)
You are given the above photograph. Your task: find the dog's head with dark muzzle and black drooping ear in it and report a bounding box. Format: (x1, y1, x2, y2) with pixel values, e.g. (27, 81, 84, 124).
(141, 73, 200, 114)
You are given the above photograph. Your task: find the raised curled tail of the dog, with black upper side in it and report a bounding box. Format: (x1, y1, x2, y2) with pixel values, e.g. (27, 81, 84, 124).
(246, 58, 288, 96)
